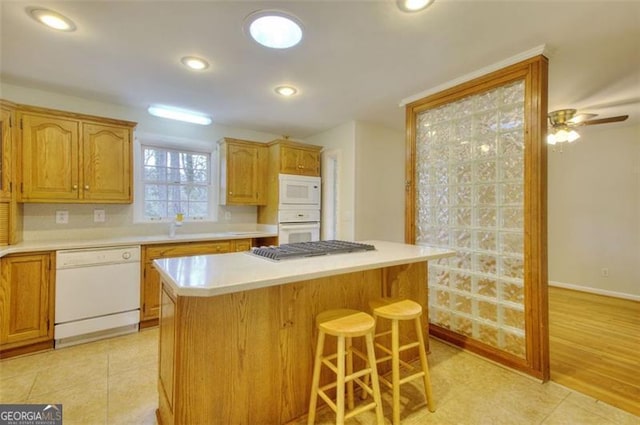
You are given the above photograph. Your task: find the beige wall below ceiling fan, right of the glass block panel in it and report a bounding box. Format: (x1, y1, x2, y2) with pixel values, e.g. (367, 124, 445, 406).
(548, 124, 640, 300)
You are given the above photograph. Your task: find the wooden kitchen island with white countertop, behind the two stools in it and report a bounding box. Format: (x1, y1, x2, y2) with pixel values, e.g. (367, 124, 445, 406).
(155, 241, 454, 425)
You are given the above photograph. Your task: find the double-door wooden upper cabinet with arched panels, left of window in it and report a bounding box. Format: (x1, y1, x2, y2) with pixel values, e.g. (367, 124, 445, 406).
(18, 106, 135, 203)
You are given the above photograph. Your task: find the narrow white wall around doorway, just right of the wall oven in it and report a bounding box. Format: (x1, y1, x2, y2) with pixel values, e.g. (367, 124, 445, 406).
(306, 121, 356, 240)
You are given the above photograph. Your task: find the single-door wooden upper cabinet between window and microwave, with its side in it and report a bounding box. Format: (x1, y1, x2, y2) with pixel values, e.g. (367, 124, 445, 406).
(218, 138, 269, 205)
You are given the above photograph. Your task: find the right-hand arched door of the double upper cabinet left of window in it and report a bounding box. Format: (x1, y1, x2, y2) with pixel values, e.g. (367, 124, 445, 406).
(81, 122, 132, 203)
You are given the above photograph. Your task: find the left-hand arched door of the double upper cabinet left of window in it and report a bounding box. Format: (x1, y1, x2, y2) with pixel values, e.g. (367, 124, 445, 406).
(20, 113, 79, 202)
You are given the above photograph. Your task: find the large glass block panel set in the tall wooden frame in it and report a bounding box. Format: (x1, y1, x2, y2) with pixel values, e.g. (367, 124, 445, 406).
(416, 80, 526, 358)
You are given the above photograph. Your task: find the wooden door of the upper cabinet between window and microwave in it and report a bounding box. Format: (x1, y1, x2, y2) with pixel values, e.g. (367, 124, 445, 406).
(227, 143, 267, 205)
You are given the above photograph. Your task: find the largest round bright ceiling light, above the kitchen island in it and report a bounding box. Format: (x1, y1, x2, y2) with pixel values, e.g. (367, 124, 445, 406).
(244, 10, 302, 49)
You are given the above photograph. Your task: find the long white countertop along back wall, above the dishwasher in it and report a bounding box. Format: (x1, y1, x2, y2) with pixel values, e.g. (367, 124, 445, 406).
(0, 228, 278, 257)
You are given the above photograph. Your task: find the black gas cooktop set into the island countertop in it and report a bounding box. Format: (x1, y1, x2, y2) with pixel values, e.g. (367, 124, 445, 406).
(251, 240, 376, 261)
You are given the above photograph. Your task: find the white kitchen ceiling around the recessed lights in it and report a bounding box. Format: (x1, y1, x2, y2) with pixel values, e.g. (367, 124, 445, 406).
(0, 0, 640, 139)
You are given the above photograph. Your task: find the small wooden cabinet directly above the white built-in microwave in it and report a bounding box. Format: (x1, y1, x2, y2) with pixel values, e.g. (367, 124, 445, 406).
(269, 140, 322, 177)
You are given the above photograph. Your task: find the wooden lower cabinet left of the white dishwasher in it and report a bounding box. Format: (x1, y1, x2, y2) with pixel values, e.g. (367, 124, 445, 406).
(0, 252, 55, 357)
